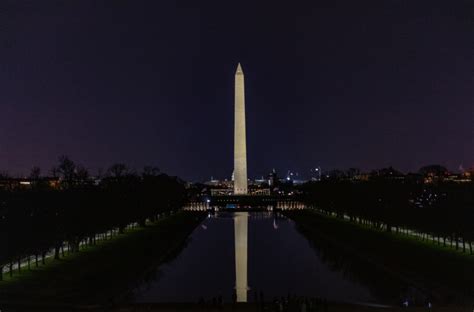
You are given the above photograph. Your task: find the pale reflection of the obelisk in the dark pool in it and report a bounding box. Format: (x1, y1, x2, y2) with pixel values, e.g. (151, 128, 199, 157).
(234, 212, 248, 302)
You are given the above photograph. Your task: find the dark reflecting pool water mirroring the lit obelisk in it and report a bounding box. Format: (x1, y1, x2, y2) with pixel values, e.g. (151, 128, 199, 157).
(135, 212, 377, 302)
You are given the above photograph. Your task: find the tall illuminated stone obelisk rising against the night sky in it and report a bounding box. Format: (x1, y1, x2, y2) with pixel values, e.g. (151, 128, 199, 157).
(234, 63, 247, 195)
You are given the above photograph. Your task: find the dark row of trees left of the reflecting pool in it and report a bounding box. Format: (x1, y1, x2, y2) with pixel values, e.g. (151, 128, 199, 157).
(0, 156, 186, 280)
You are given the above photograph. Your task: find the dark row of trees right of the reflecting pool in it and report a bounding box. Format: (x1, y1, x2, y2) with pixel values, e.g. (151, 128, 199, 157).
(301, 176, 474, 254)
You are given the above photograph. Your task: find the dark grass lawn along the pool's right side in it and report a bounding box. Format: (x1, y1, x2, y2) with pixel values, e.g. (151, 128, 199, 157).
(285, 210, 474, 304)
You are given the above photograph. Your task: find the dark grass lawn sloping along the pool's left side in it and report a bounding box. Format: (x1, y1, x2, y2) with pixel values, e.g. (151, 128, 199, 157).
(0, 212, 204, 306)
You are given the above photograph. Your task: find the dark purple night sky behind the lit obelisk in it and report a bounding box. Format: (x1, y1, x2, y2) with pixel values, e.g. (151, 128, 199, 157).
(0, 0, 474, 180)
